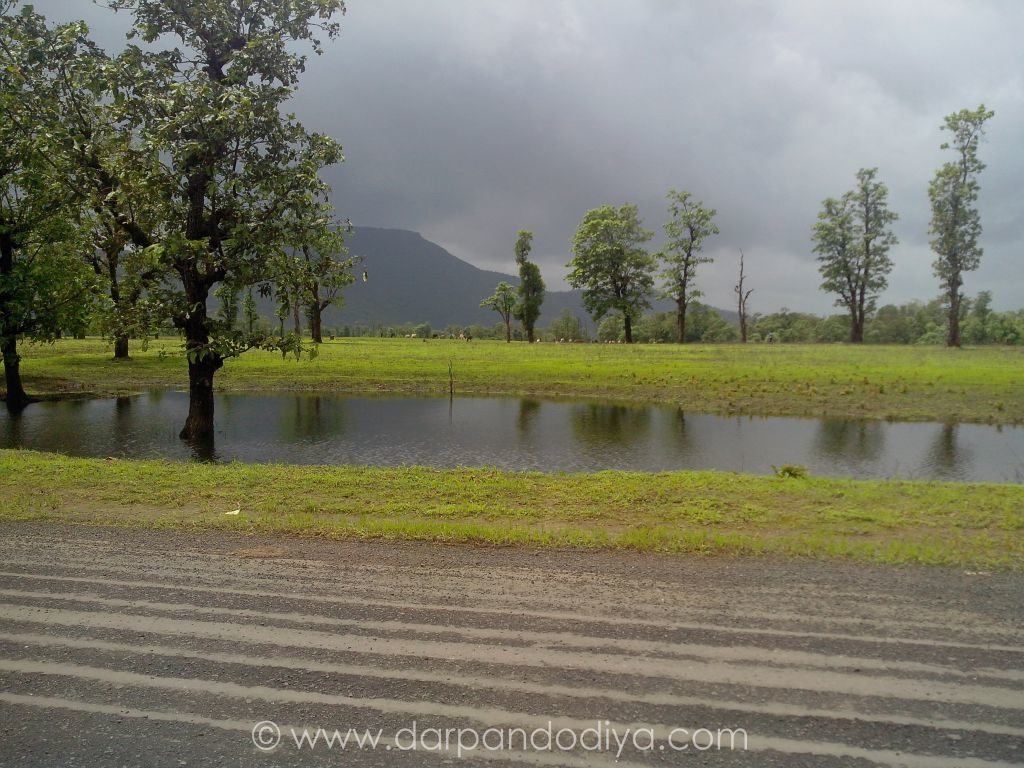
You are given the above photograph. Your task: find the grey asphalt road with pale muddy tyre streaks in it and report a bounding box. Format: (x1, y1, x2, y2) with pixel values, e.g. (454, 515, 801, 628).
(0, 524, 1024, 768)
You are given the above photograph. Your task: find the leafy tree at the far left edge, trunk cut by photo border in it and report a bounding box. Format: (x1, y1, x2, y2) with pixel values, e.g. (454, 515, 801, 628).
(0, 0, 99, 410)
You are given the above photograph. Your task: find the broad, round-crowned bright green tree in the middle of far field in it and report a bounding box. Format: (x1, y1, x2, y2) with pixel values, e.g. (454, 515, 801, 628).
(567, 203, 655, 344)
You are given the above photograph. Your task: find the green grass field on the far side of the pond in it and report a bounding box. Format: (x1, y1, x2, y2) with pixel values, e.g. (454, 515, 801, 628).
(9, 339, 1024, 424)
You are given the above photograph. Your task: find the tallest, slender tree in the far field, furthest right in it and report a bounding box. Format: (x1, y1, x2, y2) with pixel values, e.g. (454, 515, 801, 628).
(928, 104, 995, 347)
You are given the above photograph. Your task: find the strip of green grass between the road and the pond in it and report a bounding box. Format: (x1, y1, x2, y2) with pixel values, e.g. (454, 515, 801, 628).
(0, 451, 1024, 570)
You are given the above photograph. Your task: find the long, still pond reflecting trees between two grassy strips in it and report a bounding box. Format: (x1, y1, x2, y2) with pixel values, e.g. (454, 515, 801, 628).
(0, 391, 1024, 482)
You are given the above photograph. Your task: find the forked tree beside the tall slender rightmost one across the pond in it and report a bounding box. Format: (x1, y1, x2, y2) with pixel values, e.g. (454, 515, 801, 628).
(811, 168, 899, 343)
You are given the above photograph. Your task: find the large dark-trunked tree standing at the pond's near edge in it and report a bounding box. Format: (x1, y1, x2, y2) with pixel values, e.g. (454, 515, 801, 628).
(93, 0, 344, 440)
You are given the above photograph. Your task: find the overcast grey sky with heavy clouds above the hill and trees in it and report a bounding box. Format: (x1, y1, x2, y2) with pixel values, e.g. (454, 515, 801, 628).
(35, 0, 1024, 312)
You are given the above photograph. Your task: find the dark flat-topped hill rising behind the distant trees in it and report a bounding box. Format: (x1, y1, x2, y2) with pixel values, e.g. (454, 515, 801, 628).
(280, 226, 733, 328)
